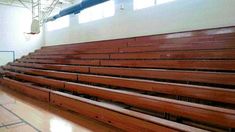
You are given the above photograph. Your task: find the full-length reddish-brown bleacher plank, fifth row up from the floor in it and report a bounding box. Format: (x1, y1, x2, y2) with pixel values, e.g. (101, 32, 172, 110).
(18, 59, 235, 71)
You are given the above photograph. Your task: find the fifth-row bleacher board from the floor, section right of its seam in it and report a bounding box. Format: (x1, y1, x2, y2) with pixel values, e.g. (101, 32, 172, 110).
(101, 60, 235, 70)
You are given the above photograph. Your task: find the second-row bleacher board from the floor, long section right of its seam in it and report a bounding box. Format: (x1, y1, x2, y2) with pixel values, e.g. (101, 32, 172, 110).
(65, 83, 235, 127)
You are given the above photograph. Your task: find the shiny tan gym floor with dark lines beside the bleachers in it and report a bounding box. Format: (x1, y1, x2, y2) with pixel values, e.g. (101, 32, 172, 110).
(0, 86, 120, 132)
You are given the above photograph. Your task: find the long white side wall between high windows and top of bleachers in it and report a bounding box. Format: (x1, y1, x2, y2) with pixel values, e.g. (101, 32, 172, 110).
(45, 0, 235, 46)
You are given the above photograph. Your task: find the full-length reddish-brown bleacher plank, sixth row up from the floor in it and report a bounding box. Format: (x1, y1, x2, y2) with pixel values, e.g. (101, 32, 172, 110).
(25, 49, 235, 60)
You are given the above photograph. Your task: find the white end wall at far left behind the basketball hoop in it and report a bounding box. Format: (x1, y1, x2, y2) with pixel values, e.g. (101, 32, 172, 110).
(0, 5, 44, 65)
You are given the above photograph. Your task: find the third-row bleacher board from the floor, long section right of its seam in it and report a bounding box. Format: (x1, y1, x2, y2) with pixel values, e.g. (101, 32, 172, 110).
(78, 74, 235, 104)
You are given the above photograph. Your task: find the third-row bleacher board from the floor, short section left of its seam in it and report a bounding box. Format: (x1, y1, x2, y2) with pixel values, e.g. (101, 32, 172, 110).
(4, 66, 77, 81)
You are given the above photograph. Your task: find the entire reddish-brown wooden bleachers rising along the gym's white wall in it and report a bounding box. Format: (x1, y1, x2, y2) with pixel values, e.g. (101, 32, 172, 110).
(1, 27, 235, 131)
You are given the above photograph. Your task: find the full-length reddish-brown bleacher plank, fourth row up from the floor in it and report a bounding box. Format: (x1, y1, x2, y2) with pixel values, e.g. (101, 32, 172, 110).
(10, 63, 235, 85)
